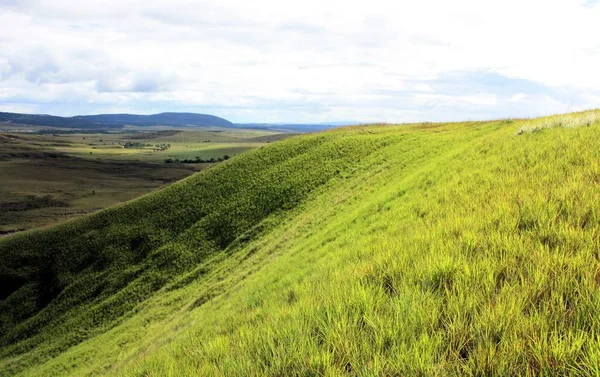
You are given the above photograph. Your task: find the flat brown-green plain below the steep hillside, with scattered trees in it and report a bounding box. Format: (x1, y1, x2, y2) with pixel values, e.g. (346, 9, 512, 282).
(0, 126, 288, 232)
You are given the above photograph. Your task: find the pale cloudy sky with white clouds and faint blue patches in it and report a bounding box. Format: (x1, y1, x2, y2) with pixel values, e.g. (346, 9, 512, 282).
(0, 0, 600, 123)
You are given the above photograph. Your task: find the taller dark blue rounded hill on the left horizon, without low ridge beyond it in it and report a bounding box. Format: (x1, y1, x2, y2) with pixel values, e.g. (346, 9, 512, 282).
(0, 112, 235, 129)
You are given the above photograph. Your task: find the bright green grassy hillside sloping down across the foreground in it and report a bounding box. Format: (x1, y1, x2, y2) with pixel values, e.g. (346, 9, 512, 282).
(0, 111, 600, 376)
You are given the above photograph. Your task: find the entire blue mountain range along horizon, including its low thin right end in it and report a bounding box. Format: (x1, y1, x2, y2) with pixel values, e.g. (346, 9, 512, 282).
(0, 112, 352, 132)
